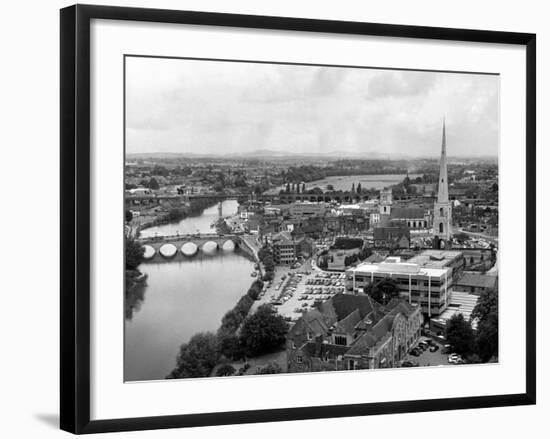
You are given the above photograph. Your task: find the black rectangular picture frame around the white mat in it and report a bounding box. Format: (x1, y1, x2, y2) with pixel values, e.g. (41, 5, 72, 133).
(60, 5, 536, 434)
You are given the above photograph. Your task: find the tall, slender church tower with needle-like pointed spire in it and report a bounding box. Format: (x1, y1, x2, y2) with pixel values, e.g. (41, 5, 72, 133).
(433, 120, 452, 248)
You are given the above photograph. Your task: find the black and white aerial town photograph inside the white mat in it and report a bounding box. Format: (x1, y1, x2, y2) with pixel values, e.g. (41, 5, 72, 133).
(124, 55, 500, 382)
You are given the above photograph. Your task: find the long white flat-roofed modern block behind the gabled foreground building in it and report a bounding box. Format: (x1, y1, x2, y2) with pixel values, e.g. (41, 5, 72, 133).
(346, 257, 460, 317)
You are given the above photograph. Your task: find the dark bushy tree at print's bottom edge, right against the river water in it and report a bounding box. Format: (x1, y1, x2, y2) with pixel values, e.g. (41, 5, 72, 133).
(168, 332, 220, 378)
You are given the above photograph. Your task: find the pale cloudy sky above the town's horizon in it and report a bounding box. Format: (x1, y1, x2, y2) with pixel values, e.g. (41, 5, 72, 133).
(126, 57, 499, 158)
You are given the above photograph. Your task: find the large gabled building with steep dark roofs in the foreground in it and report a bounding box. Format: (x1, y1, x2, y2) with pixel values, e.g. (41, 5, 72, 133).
(287, 294, 422, 373)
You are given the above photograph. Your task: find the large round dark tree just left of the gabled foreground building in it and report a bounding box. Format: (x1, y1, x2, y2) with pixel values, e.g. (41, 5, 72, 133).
(240, 304, 288, 356)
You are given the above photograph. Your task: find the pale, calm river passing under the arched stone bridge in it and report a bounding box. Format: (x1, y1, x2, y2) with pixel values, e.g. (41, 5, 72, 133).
(124, 201, 254, 381)
